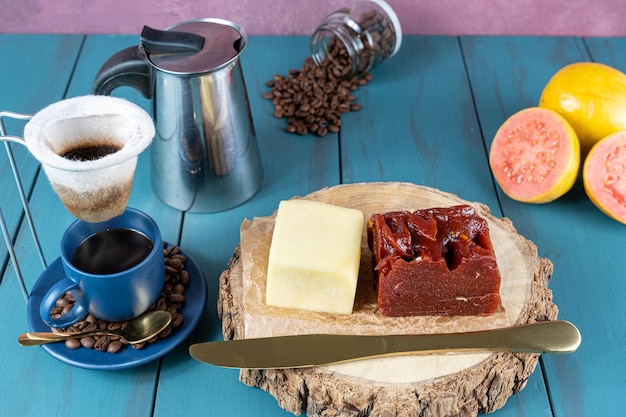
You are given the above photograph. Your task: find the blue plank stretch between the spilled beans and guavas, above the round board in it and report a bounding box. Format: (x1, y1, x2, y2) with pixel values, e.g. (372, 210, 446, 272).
(341, 36, 499, 214)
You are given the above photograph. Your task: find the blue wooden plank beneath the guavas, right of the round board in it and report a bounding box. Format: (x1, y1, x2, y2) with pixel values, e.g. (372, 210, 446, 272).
(462, 37, 626, 416)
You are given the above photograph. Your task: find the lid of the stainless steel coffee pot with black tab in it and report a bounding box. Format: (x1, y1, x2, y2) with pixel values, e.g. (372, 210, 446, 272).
(141, 19, 247, 75)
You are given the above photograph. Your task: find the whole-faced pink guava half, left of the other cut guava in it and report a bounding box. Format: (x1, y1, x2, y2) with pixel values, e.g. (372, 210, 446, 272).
(489, 107, 580, 204)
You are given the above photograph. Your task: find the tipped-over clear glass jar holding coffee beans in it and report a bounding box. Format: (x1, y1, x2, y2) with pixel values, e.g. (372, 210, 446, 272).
(310, 0, 402, 79)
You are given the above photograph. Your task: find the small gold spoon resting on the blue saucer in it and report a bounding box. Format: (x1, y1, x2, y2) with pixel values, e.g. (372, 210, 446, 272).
(17, 311, 172, 346)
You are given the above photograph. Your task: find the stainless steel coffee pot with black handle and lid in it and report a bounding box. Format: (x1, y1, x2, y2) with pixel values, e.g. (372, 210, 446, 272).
(93, 19, 263, 213)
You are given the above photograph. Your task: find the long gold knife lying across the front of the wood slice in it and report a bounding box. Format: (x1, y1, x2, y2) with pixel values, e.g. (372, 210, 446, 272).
(189, 320, 581, 369)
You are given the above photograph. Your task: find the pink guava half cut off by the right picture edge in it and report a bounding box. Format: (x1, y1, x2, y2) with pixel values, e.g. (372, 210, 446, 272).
(583, 131, 626, 224)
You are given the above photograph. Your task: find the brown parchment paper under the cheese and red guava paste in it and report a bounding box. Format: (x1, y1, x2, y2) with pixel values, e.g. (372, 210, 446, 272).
(241, 208, 510, 338)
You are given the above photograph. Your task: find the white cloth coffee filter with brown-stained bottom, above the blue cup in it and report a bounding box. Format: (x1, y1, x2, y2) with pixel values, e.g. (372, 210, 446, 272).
(24, 95, 155, 222)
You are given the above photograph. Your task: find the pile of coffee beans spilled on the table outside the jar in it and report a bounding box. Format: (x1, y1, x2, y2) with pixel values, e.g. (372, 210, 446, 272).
(263, 51, 372, 136)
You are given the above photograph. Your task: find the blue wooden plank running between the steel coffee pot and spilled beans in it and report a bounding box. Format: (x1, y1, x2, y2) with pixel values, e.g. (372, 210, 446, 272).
(155, 37, 340, 417)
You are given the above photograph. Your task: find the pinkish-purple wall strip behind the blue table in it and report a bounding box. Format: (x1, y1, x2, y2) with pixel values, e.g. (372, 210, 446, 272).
(0, 0, 626, 36)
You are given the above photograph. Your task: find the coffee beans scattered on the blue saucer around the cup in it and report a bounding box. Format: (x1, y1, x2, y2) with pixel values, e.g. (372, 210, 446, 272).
(51, 242, 189, 353)
